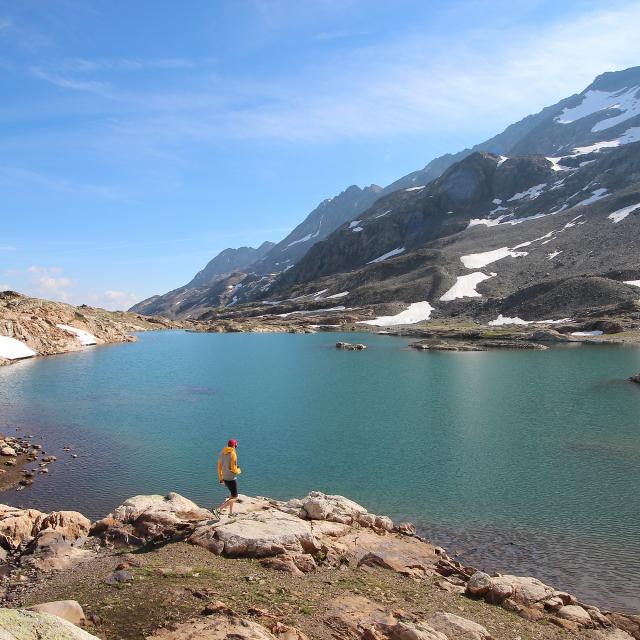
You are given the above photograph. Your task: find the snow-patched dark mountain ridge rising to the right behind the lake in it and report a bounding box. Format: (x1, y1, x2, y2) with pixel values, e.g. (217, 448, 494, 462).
(132, 67, 640, 322)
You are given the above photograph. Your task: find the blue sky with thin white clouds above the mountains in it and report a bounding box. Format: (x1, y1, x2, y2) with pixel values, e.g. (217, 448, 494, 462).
(0, 0, 640, 308)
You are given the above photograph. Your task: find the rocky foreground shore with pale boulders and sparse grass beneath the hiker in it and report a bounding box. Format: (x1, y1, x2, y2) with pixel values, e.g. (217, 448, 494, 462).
(0, 492, 640, 640)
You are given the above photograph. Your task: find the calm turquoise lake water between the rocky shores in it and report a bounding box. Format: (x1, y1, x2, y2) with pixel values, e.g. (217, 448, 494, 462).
(0, 332, 640, 612)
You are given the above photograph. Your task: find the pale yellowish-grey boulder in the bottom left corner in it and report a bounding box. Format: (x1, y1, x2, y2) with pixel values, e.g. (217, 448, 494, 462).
(0, 609, 99, 640)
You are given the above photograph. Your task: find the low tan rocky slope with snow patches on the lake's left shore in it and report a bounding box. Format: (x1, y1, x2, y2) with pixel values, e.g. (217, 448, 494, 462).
(0, 291, 183, 365)
